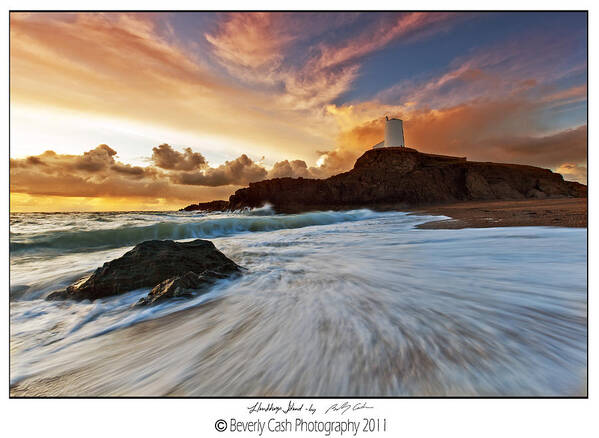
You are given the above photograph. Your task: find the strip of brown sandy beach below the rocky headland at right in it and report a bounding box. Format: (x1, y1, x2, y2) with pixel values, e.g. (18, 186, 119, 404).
(412, 198, 587, 230)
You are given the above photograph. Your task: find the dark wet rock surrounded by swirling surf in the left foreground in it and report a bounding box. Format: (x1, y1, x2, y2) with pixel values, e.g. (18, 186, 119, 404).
(46, 239, 240, 302)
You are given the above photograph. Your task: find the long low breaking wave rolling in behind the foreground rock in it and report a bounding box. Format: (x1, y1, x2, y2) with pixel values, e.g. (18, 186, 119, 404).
(10, 207, 390, 254)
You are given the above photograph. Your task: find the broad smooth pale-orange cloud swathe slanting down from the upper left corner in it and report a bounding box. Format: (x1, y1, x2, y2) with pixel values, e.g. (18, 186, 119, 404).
(10, 13, 334, 161)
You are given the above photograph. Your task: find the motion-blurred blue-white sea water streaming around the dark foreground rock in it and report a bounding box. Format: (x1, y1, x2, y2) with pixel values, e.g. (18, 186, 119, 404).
(10, 206, 587, 397)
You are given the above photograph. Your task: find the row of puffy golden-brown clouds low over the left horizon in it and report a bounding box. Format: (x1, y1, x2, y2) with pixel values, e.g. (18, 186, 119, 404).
(10, 144, 324, 211)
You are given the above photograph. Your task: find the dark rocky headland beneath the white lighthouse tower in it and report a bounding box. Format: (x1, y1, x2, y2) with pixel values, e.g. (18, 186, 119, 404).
(229, 148, 587, 211)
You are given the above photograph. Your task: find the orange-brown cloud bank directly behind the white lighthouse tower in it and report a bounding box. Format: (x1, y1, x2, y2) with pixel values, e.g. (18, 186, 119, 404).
(321, 100, 587, 179)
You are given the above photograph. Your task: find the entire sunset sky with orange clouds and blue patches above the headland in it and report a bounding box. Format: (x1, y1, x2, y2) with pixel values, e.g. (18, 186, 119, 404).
(10, 12, 587, 212)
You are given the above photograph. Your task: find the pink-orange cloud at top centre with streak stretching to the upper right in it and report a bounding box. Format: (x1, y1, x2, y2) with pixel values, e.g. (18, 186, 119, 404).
(205, 12, 466, 110)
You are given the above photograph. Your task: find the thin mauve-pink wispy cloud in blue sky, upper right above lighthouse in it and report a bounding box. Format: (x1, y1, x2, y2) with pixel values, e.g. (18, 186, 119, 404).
(375, 28, 586, 109)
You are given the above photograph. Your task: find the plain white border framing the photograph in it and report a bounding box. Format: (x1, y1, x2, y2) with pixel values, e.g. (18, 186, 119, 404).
(0, 0, 599, 438)
